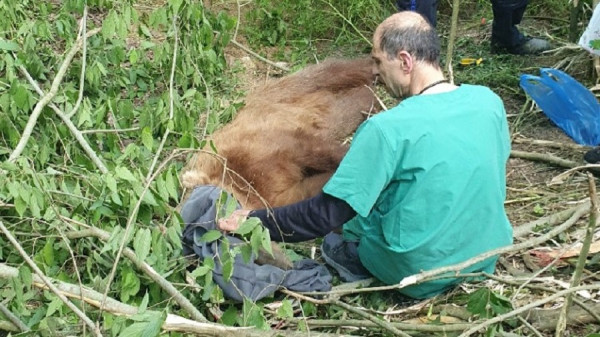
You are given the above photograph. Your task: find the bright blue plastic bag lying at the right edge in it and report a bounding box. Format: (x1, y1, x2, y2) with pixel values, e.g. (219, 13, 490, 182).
(519, 68, 600, 146)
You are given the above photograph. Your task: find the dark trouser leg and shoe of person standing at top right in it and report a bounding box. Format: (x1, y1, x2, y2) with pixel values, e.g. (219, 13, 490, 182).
(491, 0, 550, 54)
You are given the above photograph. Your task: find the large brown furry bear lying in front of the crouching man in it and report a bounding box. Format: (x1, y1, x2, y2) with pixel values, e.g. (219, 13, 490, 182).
(183, 59, 380, 209)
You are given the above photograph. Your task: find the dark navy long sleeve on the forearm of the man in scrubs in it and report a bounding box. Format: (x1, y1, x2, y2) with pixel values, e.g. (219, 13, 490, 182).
(248, 192, 356, 242)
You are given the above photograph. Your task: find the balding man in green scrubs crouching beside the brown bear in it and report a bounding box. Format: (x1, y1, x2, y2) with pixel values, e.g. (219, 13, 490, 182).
(219, 12, 512, 298)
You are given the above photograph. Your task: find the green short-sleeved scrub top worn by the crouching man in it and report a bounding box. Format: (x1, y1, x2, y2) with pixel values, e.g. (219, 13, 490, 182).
(323, 84, 512, 298)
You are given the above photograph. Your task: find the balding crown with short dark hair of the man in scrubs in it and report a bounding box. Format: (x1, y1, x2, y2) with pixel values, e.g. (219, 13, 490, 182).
(373, 11, 440, 67)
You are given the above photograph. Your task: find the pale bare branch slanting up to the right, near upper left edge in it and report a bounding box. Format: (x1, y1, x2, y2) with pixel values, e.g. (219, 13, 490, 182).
(8, 28, 100, 162)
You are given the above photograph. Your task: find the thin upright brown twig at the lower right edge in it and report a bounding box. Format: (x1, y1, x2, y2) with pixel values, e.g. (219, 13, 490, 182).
(555, 172, 598, 337)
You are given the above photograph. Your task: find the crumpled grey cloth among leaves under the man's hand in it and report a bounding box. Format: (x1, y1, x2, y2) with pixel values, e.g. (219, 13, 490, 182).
(181, 185, 331, 301)
